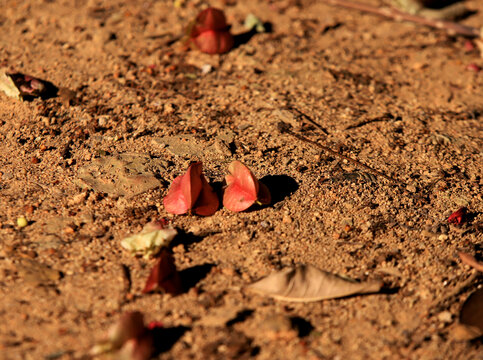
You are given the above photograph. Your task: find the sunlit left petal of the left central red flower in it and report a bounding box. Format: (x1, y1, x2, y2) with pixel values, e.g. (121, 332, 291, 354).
(163, 162, 202, 215)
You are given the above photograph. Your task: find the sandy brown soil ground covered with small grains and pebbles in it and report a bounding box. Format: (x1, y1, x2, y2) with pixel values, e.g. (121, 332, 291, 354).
(0, 0, 483, 359)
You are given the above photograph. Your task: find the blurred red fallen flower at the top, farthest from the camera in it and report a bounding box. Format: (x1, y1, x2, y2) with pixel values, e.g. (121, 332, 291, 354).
(188, 7, 234, 54)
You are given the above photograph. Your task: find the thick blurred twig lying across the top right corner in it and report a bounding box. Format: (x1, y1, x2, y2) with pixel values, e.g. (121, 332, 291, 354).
(327, 0, 480, 37)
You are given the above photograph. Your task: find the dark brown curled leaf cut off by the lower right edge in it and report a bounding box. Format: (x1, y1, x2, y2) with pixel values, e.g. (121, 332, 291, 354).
(454, 289, 483, 340)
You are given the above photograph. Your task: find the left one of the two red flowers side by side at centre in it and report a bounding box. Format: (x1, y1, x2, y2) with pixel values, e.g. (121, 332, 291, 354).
(163, 162, 220, 216)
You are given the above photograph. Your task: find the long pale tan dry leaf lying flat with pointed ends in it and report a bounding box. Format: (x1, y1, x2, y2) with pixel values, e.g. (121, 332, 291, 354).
(248, 265, 382, 302)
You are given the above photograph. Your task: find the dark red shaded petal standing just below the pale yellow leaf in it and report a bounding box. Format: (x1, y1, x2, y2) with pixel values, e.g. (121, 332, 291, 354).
(143, 250, 182, 295)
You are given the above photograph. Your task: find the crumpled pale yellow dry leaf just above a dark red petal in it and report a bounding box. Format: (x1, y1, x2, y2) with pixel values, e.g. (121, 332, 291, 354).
(121, 222, 178, 258)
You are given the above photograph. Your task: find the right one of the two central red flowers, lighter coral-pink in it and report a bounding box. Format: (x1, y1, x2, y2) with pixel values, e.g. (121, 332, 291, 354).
(223, 161, 271, 212)
